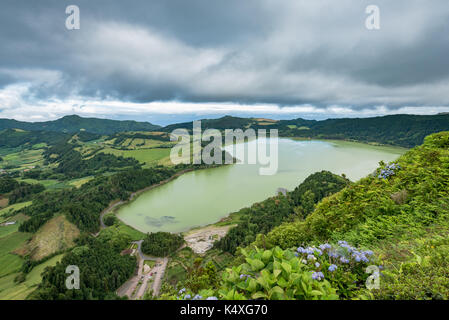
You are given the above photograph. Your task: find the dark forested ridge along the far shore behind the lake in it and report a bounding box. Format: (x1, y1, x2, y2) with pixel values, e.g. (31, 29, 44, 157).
(161, 114, 449, 148)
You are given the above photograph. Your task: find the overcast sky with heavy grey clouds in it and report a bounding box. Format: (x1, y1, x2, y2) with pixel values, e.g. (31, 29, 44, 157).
(0, 0, 449, 124)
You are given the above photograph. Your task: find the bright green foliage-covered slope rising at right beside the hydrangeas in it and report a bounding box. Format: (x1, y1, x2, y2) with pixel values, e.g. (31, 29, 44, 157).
(258, 132, 449, 299)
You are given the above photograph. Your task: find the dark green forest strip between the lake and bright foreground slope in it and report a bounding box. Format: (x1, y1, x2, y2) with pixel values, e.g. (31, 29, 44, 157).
(215, 171, 349, 253)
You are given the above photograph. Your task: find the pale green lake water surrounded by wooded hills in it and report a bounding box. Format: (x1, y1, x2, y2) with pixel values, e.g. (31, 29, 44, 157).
(117, 139, 404, 232)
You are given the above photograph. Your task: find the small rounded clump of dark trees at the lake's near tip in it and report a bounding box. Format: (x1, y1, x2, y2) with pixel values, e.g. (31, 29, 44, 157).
(141, 232, 184, 257)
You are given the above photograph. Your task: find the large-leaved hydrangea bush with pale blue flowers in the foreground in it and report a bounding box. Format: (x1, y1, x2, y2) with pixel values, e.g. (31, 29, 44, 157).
(177, 241, 375, 300)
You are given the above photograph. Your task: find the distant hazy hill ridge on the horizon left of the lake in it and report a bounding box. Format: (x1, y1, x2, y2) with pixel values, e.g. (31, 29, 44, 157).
(0, 115, 160, 134)
